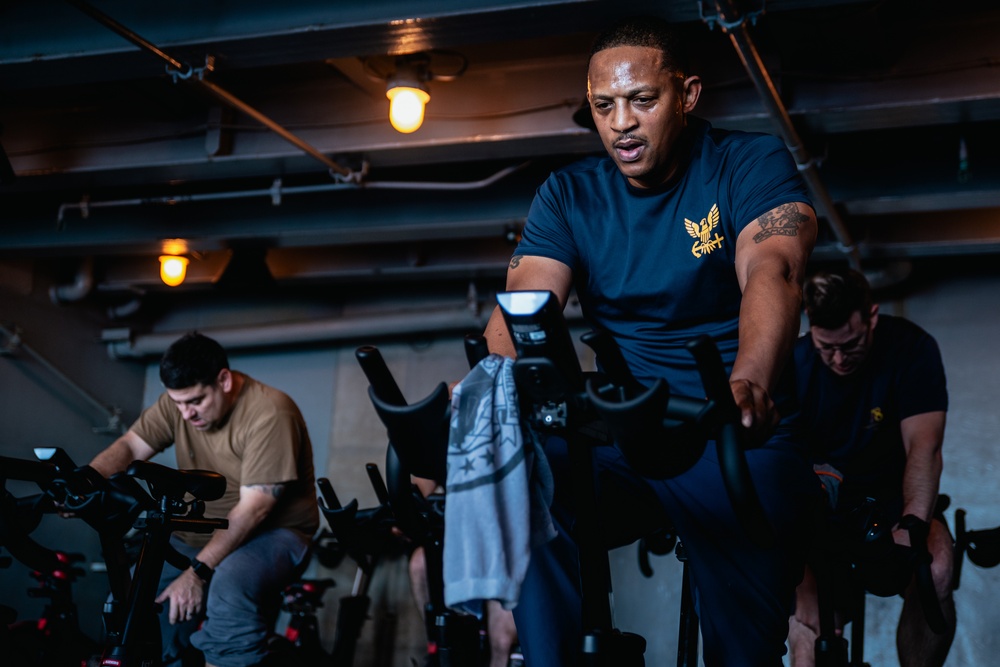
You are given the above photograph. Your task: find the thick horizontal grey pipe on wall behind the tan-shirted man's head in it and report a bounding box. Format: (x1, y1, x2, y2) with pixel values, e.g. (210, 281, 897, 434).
(104, 300, 582, 359)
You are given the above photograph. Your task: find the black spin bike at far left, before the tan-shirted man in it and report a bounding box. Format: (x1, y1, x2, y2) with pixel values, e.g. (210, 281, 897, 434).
(0, 448, 228, 667)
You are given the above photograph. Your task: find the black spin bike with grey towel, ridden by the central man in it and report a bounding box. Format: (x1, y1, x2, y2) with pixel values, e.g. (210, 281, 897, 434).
(362, 292, 773, 667)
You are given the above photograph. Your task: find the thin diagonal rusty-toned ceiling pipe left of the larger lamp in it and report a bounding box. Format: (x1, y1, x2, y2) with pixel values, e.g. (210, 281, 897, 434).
(66, 0, 366, 182)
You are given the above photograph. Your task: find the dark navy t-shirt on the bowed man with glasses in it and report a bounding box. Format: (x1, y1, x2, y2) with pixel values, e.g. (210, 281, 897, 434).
(795, 315, 948, 502)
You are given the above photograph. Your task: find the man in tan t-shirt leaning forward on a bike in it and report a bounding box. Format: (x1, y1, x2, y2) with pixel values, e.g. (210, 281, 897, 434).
(90, 333, 319, 667)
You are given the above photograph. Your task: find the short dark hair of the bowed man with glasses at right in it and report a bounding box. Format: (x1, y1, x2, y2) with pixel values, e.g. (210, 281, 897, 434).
(802, 269, 872, 329)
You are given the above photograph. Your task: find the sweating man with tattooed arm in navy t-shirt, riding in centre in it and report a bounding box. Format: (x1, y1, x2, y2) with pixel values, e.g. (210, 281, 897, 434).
(486, 13, 816, 667)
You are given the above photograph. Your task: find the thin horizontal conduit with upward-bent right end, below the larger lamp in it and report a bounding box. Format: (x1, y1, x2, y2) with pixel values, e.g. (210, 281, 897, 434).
(56, 162, 529, 228)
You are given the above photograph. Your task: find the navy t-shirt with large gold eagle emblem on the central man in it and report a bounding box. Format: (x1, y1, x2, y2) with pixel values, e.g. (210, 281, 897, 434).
(515, 117, 809, 396)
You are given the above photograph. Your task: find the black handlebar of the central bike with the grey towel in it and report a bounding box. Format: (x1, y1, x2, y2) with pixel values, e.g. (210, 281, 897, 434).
(356, 298, 774, 548)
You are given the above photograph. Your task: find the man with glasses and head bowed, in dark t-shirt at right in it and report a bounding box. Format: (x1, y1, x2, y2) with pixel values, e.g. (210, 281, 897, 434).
(789, 269, 955, 667)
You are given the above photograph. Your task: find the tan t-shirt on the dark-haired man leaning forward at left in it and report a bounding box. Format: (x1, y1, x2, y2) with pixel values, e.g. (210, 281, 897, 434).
(132, 371, 319, 546)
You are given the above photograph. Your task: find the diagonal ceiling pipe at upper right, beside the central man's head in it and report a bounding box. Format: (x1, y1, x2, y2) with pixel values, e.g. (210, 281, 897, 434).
(698, 0, 861, 271)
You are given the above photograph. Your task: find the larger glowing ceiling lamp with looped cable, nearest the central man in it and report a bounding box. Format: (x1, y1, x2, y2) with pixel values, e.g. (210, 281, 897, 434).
(364, 51, 468, 134)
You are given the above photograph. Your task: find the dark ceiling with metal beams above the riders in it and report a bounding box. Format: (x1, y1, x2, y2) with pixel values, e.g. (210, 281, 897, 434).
(0, 0, 1000, 306)
